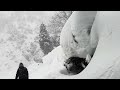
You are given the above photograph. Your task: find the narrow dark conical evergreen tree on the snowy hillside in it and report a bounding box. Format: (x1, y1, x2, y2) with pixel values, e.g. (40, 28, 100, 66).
(39, 23, 53, 55)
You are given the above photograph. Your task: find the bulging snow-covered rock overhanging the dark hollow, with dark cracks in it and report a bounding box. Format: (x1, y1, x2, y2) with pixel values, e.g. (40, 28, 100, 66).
(60, 11, 96, 58)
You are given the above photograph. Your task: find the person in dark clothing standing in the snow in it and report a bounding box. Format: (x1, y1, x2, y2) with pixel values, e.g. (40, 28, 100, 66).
(15, 63, 29, 79)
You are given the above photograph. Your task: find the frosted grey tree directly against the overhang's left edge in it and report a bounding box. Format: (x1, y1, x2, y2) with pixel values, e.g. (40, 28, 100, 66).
(47, 11, 72, 47)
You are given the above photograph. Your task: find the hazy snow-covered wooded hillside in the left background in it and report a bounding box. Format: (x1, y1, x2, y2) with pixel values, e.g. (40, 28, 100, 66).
(0, 11, 54, 79)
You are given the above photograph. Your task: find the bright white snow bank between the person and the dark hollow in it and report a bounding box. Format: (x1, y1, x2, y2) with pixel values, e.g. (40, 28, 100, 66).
(30, 46, 65, 79)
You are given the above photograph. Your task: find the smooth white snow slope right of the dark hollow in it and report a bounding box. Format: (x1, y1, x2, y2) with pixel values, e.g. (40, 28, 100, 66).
(72, 11, 120, 79)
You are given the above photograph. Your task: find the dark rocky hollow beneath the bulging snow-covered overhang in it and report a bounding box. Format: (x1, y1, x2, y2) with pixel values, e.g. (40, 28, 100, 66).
(64, 57, 88, 75)
